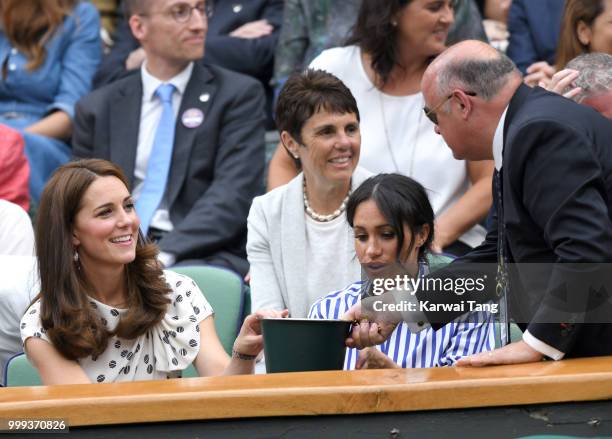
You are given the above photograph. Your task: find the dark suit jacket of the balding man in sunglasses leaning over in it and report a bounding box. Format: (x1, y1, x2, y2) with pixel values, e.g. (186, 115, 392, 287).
(417, 85, 612, 357)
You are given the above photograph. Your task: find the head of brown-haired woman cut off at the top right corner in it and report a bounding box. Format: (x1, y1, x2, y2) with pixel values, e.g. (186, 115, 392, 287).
(556, 0, 612, 71)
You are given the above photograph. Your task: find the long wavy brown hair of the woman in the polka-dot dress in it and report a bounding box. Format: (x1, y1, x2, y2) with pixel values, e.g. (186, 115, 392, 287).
(34, 159, 170, 360)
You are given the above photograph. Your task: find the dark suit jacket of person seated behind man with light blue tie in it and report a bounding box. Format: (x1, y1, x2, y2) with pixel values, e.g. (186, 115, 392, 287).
(93, 0, 283, 88)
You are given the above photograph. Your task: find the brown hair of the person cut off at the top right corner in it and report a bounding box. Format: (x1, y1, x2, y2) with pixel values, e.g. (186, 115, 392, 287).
(556, 0, 604, 70)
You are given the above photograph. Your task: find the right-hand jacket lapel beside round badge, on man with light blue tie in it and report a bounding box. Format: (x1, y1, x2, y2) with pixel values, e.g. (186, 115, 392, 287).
(167, 63, 217, 206)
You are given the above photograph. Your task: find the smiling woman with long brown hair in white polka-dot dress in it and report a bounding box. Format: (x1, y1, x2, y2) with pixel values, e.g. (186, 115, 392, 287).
(21, 159, 286, 384)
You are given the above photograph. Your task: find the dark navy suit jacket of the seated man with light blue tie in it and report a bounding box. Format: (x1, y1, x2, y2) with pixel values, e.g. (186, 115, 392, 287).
(72, 64, 264, 272)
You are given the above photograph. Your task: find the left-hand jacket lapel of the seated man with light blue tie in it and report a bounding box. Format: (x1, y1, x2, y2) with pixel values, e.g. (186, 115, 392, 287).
(109, 74, 142, 188)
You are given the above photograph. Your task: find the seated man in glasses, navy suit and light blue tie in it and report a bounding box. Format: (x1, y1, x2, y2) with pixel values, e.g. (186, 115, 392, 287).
(73, 0, 265, 275)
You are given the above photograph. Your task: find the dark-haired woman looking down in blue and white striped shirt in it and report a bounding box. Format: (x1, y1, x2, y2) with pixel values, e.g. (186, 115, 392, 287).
(309, 174, 495, 370)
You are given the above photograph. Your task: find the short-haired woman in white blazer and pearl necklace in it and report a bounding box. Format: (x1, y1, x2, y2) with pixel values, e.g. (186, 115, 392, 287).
(247, 70, 371, 317)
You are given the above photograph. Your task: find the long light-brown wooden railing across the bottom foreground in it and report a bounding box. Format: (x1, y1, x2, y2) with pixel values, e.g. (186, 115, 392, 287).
(0, 357, 612, 426)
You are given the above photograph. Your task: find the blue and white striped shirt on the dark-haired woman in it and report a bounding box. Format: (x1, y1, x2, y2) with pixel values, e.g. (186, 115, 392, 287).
(308, 281, 495, 370)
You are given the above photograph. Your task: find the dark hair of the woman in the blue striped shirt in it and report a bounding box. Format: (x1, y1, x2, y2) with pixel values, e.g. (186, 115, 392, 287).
(346, 174, 434, 260)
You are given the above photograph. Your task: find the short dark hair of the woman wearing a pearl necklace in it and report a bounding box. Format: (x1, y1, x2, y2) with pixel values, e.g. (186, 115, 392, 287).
(276, 69, 359, 143)
